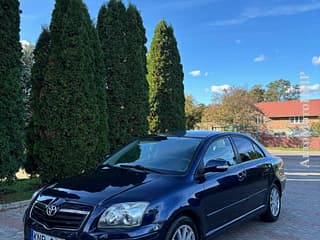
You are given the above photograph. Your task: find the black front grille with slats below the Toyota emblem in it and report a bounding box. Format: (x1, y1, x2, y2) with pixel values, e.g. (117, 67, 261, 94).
(30, 201, 92, 230)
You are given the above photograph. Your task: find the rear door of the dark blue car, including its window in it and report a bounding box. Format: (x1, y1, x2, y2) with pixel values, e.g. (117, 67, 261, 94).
(232, 136, 272, 212)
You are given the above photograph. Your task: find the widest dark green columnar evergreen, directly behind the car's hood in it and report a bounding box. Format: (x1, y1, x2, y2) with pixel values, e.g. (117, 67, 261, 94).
(34, 0, 108, 181)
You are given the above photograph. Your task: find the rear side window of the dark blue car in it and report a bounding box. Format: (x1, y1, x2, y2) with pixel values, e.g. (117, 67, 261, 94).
(233, 137, 264, 162)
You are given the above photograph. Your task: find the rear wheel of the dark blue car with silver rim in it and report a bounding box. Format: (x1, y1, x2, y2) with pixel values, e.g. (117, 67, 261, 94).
(260, 184, 281, 222)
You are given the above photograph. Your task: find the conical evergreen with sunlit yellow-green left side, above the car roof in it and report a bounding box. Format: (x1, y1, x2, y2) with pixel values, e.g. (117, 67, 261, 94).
(147, 20, 185, 133)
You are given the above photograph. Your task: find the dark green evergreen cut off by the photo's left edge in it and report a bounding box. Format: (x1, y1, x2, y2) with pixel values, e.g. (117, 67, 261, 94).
(0, 0, 24, 180)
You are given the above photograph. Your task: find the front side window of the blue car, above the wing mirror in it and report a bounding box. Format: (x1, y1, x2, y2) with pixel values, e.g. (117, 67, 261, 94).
(203, 137, 236, 165)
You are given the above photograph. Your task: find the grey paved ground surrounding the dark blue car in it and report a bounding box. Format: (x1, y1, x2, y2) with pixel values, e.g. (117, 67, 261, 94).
(0, 155, 320, 240)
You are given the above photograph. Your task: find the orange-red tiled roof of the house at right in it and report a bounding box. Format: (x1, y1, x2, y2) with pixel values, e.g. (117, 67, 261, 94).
(256, 99, 320, 117)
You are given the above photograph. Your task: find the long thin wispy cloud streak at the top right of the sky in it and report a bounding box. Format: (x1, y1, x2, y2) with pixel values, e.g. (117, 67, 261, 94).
(212, 1, 320, 26)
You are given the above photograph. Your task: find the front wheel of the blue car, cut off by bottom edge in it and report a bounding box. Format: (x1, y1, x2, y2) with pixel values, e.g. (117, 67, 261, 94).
(165, 216, 200, 240)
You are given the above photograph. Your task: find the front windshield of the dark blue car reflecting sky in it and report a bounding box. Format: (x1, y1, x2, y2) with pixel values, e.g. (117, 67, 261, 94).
(103, 136, 201, 173)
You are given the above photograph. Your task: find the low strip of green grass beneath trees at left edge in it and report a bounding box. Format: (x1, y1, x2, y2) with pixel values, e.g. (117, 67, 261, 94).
(0, 178, 41, 204)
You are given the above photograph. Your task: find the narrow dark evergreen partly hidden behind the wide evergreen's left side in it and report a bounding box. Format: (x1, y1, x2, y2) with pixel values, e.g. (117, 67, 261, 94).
(24, 28, 50, 174)
